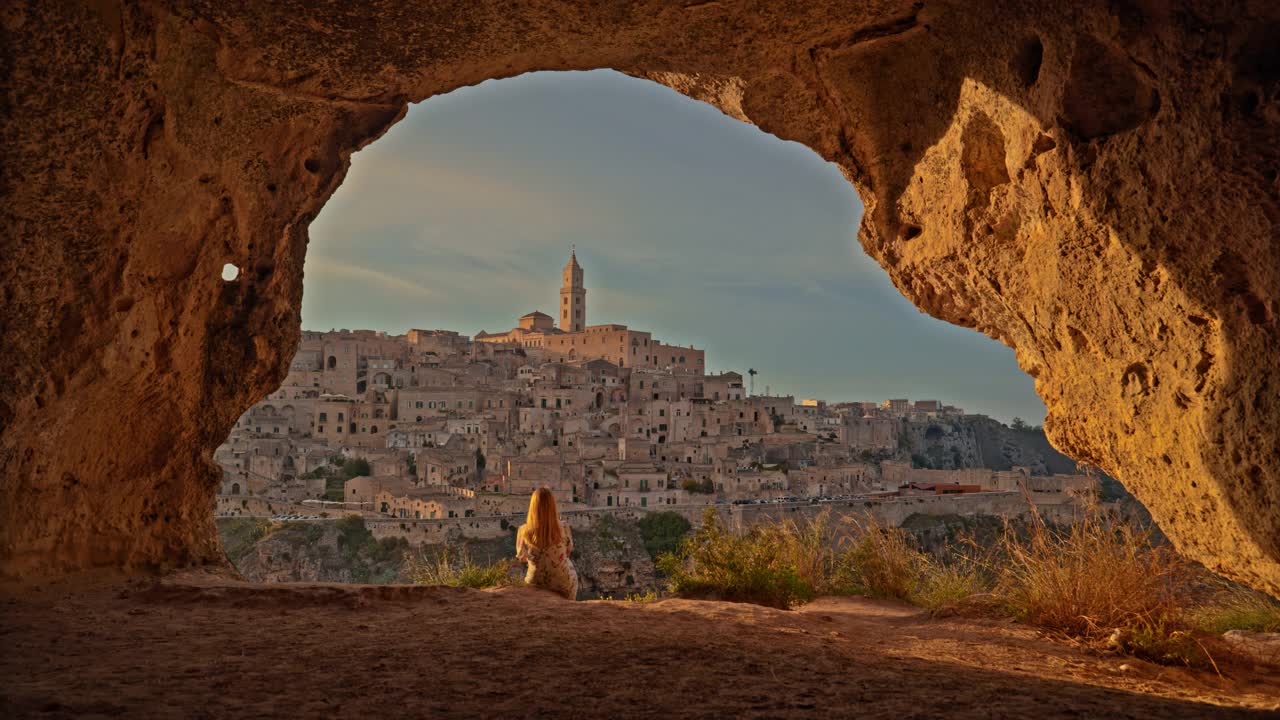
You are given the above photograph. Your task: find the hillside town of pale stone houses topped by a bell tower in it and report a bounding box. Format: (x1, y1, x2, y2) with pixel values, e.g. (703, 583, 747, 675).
(215, 254, 1094, 542)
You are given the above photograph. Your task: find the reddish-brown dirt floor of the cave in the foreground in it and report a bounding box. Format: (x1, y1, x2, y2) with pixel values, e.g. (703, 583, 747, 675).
(0, 574, 1280, 720)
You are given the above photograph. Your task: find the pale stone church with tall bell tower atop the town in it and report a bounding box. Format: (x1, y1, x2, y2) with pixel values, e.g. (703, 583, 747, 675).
(475, 251, 707, 375)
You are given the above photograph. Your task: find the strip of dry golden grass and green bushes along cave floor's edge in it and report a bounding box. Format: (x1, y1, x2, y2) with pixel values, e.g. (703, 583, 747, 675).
(659, 506, 1280, 667)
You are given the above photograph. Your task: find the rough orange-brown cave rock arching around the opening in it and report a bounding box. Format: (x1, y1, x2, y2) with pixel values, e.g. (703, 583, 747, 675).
(0, 0, 1280, 593)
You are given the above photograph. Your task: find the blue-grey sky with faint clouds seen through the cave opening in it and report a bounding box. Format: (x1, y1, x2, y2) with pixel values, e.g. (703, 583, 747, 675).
(302, 70, 1044, 423)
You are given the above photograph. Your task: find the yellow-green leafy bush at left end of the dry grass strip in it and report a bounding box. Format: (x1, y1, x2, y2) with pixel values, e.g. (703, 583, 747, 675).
(658, 509, 814, 609)
